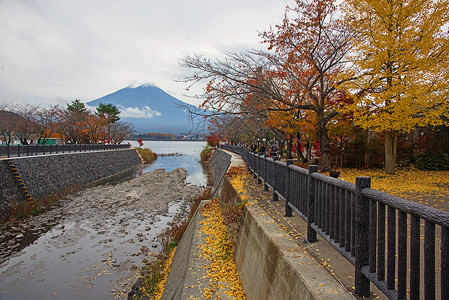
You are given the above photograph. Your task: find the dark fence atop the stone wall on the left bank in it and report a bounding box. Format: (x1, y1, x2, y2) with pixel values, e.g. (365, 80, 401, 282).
(0, 144, 131, 158)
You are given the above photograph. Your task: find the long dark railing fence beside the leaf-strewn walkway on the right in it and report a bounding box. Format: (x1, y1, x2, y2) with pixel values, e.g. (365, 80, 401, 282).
(221, 145, 449, 299)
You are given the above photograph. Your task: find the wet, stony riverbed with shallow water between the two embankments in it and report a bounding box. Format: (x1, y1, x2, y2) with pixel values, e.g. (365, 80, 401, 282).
(0, 169, 201, 299)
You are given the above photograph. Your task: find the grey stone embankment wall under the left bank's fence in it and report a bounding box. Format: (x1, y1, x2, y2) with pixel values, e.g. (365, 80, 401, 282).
(0, 149, 141, 216)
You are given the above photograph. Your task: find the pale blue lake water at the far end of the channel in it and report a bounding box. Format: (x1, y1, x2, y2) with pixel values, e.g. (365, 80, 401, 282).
(129, 141, 207, 186)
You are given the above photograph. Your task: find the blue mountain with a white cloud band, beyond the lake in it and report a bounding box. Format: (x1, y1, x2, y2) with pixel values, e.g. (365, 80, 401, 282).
(87, 85, 199, 133)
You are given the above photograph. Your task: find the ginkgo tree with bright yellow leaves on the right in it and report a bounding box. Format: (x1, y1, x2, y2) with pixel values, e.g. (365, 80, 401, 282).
(342, 0, 449, 174)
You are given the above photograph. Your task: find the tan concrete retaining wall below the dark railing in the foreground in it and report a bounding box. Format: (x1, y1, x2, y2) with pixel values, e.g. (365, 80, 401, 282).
(235, 199, 354, 299)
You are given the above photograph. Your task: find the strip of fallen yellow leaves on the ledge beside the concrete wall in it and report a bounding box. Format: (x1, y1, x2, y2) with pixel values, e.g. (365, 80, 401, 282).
(200, 199, 246, 299)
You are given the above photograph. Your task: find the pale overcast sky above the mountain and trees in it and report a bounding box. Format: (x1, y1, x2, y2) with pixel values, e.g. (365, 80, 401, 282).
(0, 0, 286, 104)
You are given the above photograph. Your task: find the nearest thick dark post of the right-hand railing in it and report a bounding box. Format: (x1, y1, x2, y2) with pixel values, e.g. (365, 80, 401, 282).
(355, 177, 371, 297)
